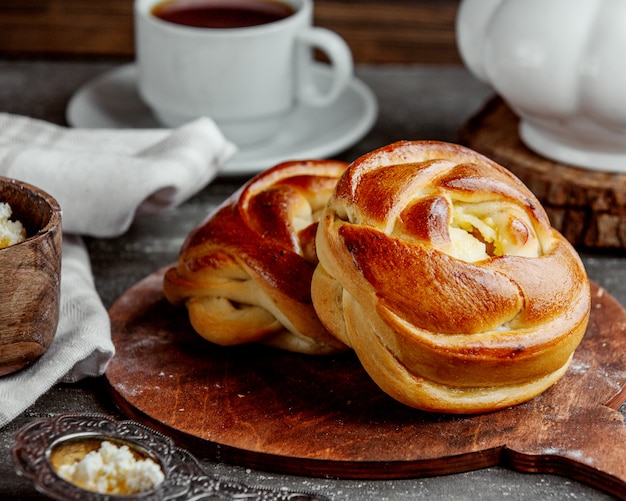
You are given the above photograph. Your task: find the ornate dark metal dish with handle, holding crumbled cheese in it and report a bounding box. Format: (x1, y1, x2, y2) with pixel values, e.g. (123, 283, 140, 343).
(11, 414, 328, 501)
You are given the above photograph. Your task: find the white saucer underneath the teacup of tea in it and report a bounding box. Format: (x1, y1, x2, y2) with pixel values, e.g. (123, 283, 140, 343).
(66, 64, 378, 174)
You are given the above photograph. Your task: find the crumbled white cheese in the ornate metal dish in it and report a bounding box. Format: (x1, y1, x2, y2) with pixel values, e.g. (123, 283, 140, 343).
(58, 440, 165, 495)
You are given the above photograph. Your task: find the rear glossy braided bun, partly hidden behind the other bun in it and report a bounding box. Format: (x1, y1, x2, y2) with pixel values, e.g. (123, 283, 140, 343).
(163, 161, 347, 354)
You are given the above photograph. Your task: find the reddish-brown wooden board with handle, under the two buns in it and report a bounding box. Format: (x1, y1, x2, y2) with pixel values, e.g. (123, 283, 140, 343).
(106, 270, 626, 497)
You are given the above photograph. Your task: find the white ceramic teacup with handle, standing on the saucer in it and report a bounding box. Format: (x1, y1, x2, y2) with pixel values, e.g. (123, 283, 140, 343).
(135, 0, 353, 145)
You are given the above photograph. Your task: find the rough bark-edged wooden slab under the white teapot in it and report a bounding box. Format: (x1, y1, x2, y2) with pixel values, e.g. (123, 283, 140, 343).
(459, 97, 626, 249)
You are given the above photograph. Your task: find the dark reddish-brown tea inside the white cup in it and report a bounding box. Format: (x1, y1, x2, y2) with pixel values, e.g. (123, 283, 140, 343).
(152, 0, 294, 29)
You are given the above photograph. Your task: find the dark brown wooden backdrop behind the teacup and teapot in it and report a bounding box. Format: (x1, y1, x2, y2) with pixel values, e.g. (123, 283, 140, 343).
(0, 0, 460, 64)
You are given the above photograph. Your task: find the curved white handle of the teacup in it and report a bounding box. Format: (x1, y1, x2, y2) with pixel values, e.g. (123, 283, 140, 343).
(298, 26, 354, 106)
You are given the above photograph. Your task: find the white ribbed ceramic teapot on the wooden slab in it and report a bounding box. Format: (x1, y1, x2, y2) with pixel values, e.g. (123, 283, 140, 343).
(456, 0, 626, 172)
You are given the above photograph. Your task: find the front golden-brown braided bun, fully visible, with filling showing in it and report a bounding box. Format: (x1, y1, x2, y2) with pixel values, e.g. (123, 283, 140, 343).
(312, 141, 590, 413)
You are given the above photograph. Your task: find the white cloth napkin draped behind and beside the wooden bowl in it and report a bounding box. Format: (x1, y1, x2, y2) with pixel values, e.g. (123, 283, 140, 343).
(0, 113, 236, 427)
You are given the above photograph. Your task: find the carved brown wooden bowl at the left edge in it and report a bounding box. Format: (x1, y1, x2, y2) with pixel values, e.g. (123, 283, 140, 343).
(0, 177, 61, 376)
